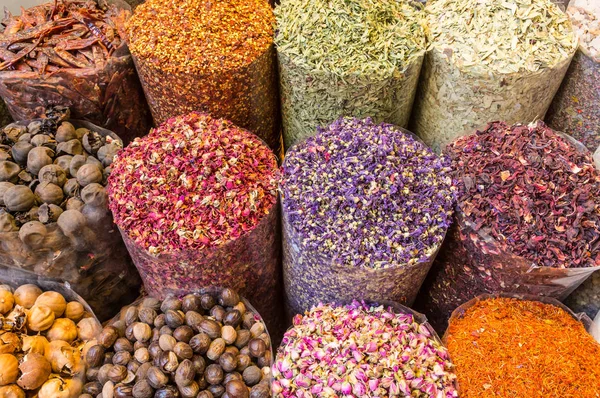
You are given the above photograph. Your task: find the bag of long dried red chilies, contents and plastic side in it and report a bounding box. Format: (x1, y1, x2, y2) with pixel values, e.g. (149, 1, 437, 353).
(0, 0, 152, 143)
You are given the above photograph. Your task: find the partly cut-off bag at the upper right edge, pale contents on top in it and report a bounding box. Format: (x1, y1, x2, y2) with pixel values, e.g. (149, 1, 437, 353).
(546, 0, 600, 151)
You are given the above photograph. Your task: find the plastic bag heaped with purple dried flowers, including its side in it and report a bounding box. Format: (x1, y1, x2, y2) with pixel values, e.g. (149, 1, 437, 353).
(280, 118, 454, 314)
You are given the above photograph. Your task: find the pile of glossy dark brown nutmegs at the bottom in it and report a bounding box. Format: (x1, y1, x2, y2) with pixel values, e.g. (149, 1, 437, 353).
(79, 289, 273, 398)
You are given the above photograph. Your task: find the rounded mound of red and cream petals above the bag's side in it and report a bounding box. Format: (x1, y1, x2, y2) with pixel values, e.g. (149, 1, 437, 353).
(108, 113, 278, 254)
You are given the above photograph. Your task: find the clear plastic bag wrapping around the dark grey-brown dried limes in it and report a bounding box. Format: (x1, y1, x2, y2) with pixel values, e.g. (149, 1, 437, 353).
(0, 120, 141, 320)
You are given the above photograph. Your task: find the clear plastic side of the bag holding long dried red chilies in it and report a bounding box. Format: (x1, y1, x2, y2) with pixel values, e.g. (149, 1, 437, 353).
(0, 0, 152, 145)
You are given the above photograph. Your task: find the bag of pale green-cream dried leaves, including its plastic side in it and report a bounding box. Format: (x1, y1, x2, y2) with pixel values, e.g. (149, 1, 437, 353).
(411, 0, 577, 150)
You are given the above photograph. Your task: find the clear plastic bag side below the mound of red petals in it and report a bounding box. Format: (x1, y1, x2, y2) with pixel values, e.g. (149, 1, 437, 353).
(121, 203, 284, 339)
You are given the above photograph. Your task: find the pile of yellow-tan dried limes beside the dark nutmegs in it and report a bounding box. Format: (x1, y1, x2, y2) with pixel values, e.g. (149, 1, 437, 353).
(0, 280, 101, 398)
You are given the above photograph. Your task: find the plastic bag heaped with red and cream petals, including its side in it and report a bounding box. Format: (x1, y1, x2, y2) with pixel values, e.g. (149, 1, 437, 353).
(108, 113, 280, 332)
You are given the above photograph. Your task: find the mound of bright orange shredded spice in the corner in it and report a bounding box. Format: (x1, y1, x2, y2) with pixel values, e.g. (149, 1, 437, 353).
(445, 298, 600, 398)
